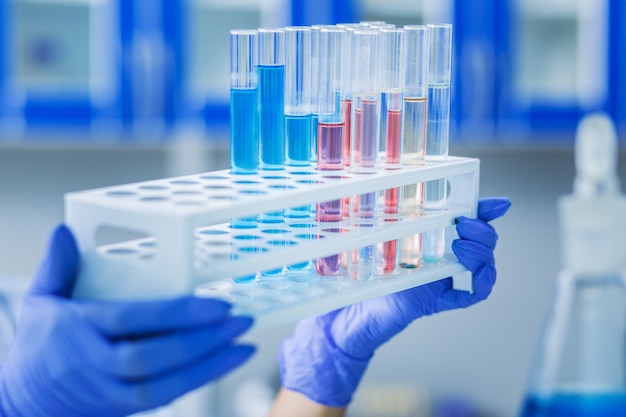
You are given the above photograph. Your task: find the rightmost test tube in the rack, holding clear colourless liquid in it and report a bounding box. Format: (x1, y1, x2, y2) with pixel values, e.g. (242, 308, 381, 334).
(422, 24, 452, 262)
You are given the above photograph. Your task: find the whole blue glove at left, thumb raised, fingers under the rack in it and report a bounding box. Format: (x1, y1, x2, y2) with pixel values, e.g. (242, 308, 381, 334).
(0, 226, 254, 417)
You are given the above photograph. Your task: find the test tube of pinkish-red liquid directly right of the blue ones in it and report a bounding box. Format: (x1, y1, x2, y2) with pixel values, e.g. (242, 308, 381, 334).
(315, 28, 346, 275)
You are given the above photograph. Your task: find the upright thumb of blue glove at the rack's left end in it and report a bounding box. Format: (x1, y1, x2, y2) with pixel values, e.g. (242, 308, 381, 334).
(30, 224, 79, 297)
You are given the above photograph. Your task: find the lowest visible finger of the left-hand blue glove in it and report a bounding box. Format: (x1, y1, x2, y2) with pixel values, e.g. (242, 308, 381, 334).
(115, 344, 255, 411)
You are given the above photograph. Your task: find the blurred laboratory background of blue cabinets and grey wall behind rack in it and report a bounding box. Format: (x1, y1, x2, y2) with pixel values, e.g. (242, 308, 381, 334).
(0, 0, 626, 417)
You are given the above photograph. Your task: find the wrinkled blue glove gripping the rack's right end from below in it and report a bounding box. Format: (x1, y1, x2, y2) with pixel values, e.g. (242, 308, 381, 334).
(279, 198, 511, 407)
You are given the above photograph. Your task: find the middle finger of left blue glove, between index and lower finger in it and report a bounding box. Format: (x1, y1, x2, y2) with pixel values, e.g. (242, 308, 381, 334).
(100, 317, 253, 380)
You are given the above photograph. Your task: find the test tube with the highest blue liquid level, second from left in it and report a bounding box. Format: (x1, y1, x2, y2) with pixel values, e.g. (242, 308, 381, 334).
(257, 28, 286, 277)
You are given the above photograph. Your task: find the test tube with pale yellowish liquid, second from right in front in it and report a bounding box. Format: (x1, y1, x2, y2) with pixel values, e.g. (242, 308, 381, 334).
(398, 25, 430, 268)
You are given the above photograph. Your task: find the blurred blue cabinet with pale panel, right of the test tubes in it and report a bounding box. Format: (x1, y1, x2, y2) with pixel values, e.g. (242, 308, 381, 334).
(453, 0, 626, 142)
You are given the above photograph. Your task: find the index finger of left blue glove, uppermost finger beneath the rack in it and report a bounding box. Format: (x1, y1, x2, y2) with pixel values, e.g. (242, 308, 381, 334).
(80, 296, 231, 338)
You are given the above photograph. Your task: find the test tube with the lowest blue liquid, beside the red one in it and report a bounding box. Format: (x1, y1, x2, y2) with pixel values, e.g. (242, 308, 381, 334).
(285, 26, 312, 271)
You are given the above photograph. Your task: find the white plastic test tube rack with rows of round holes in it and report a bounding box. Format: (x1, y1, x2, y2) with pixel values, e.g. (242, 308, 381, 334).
(65, 156, 480, 329)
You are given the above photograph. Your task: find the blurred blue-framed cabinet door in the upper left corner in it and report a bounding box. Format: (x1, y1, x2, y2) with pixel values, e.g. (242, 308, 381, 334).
(0, 0, 121, 136)
